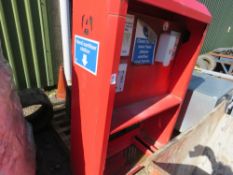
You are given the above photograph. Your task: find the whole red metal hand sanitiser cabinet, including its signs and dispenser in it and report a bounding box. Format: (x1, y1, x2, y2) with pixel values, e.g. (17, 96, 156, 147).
(71, 0, 211, 175)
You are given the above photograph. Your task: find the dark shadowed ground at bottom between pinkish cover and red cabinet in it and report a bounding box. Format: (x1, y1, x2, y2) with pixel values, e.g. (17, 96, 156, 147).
(34, 127, 71, 175)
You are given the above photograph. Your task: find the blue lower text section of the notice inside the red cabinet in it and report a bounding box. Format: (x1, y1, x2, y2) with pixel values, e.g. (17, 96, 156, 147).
(132, 38, 155, 64)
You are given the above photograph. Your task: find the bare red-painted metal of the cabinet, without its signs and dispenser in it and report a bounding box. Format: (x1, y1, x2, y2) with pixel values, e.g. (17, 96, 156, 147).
(71, 0, 211, 175)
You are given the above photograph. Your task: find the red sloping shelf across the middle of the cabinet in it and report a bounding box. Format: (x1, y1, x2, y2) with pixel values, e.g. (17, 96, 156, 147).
(110, 94, 182, 134)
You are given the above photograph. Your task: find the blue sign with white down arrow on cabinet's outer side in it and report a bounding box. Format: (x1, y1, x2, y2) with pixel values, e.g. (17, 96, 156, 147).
(74, 35, 99, 75)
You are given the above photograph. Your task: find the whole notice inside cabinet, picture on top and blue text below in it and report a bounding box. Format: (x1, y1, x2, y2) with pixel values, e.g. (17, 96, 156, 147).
(132, 19, 158, 64)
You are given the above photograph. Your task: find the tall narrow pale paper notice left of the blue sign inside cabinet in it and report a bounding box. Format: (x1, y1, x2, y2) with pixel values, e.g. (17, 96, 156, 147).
(121, 15, 134, 56)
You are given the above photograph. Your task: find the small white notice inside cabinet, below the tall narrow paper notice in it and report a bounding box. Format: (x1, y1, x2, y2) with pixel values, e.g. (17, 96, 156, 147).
(116, 63, 127, 92)
